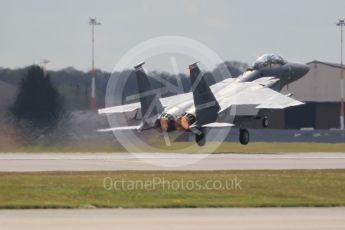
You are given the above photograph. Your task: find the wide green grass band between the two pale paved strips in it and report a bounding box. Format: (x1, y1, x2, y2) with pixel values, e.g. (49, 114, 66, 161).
(0, 170, 345, 208)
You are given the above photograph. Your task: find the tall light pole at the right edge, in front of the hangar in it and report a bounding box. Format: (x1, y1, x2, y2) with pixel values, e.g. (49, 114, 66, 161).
(337, 18, 345, 130)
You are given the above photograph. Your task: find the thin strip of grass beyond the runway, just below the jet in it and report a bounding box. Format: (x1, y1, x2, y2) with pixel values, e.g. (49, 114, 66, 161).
(0, 142, 345, 153)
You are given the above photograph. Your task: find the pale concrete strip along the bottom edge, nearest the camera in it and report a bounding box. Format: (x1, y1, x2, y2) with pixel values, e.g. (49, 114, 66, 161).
(0, 207, 345, 230)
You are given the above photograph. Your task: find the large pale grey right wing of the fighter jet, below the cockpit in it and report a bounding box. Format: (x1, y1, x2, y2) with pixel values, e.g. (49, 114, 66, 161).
(216, 82, 304, 112)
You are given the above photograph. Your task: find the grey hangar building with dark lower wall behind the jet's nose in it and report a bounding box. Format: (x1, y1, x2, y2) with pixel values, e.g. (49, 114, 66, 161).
(271, 60, 345, 129)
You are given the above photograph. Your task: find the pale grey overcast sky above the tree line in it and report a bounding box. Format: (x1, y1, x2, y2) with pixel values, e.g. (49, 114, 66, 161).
(0, 0, 345, 71)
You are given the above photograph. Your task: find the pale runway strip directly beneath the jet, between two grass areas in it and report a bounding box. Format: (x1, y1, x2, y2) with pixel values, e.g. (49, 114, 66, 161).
(0, 153, 345, 172)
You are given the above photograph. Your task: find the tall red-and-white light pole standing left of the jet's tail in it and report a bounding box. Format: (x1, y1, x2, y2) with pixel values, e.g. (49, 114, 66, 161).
(89, 18, 101, 110)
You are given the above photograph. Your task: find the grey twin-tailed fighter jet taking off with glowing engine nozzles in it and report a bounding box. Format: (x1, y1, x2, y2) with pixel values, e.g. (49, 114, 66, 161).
(98, 54, 309, 146)
